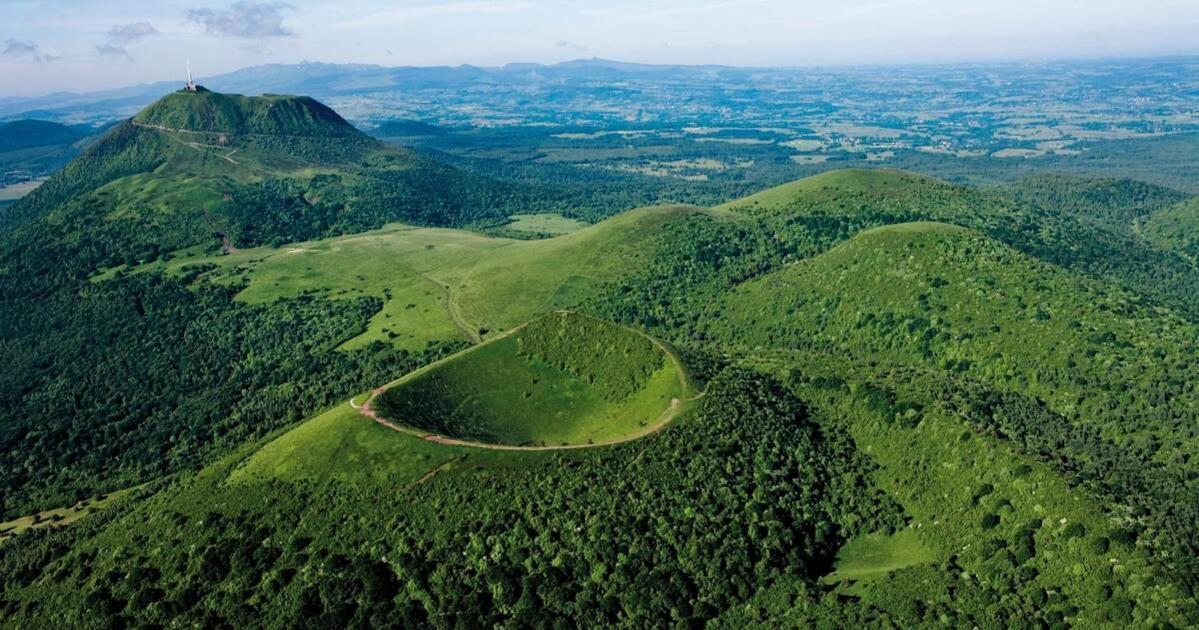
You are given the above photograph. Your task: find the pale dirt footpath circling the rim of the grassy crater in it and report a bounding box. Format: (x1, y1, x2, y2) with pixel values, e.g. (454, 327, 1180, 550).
(350, 311, 705, 451)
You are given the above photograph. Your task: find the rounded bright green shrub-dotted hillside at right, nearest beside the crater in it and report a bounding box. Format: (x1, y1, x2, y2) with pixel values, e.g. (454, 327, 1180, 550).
(704, 223, 1199, 580)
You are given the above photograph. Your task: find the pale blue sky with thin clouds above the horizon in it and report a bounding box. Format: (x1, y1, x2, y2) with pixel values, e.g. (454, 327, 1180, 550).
(0, 0, 1199, 97)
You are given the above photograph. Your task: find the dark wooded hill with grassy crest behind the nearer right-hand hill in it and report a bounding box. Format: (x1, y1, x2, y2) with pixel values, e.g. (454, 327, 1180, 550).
(722, 170, 1199, 313)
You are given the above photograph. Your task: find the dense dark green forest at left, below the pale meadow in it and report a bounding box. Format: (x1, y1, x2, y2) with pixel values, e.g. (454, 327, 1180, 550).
(0, 268, 457, 516)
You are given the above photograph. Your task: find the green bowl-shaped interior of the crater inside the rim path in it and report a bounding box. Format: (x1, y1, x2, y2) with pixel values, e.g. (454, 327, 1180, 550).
(369, 312, 688, 446)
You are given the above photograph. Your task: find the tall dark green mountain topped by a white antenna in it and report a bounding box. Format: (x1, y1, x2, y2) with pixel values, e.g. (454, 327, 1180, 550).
(8, 91, 537, 253)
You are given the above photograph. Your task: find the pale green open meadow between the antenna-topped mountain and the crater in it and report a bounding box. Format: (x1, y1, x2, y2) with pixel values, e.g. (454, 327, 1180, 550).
(125, 206, 697, 349)
